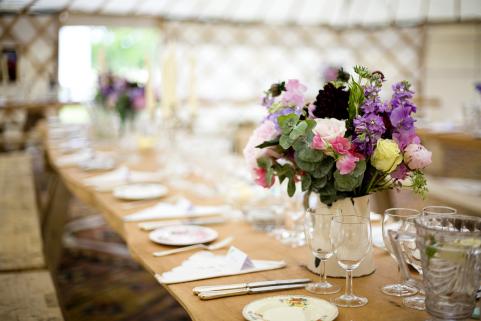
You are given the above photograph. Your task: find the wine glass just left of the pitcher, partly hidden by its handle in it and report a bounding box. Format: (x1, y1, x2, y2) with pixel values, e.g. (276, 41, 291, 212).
(382, 208, 420, 296)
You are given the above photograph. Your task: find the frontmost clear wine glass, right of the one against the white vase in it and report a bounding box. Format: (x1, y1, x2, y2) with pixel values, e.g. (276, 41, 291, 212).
(330, 215, 372, 307)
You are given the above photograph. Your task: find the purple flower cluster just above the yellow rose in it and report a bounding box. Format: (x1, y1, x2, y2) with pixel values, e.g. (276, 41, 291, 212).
(352, 113, 386, 155)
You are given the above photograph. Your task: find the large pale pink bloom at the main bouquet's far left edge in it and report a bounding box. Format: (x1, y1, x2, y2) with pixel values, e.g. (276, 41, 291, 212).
(243, 120, 278, 169)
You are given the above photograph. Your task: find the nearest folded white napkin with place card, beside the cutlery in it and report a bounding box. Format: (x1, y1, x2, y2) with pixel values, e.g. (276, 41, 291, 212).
(155, 246, 286, 284)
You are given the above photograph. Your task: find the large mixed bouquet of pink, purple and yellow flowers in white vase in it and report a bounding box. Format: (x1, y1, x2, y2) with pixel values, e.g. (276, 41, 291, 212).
(244, 66, 431, 205)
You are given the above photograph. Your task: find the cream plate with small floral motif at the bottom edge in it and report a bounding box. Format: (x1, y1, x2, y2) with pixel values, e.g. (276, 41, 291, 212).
(242, 295, 339, 321)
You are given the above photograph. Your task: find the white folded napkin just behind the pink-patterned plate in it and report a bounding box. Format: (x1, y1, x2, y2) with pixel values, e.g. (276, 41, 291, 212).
(123, 198, 229, 222)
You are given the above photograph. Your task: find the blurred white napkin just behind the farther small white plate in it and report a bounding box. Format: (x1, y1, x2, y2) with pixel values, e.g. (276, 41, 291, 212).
(84, 166, 165, 192)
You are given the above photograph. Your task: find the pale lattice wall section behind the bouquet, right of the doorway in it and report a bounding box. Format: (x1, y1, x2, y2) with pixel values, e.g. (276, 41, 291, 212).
(164, 22, 425, 102)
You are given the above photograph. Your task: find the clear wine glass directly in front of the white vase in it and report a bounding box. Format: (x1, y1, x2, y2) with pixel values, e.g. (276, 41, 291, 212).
(304, 208, 341, 294)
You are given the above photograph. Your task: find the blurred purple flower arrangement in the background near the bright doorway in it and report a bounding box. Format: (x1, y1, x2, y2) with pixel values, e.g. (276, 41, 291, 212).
(95, 73, 145, 124)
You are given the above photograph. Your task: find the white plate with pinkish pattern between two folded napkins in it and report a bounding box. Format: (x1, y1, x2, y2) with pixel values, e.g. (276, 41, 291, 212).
(149, 225, 218, 246)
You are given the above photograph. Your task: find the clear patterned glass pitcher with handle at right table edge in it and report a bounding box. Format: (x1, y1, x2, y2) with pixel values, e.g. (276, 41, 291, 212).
(389, 215, 481, 320)
